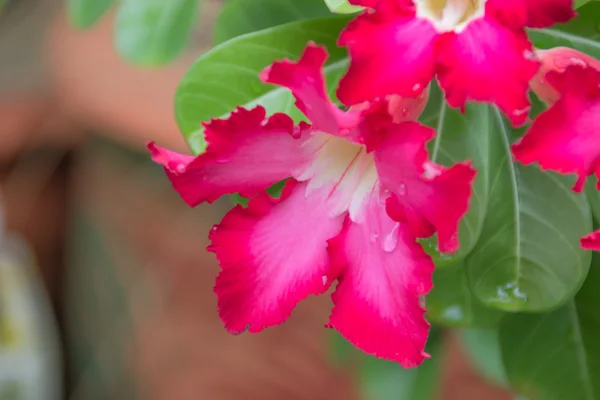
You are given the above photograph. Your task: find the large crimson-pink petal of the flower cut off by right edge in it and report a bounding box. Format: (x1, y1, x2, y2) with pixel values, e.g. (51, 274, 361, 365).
(513, 66, 600, 192)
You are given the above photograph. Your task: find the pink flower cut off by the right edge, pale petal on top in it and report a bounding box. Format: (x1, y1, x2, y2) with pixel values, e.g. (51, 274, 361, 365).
(513, 47, 600, 251)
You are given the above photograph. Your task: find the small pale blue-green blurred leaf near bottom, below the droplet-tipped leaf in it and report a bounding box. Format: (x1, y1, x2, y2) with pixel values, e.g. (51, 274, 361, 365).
(459, 329, 508, 386)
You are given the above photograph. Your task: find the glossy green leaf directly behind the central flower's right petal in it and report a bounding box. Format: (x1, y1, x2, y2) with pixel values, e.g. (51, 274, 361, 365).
(420, 84, 492, 267)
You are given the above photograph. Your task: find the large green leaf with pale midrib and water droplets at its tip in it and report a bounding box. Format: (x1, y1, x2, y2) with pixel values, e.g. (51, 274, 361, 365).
(466, 111, 592, 311)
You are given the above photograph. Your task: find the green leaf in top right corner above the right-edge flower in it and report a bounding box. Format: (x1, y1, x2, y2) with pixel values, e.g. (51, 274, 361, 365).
(529, 1, 600, 59)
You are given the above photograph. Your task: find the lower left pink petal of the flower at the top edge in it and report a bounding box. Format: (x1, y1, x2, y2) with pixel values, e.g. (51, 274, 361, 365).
(337, 6, 438, 105)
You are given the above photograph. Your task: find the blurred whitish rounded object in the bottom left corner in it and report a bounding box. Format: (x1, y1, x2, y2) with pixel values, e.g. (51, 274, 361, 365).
(0, 200, 62, 400)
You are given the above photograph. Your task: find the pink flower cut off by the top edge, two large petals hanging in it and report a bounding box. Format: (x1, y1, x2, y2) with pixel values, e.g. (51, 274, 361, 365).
(338, 0, 575, 125)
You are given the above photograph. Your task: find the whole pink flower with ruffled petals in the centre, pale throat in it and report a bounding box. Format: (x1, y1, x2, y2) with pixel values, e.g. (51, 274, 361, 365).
(149, 44, 475, 367)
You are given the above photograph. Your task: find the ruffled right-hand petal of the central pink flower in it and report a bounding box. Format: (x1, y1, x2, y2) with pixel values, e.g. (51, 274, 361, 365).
(374, 122, 476, 253)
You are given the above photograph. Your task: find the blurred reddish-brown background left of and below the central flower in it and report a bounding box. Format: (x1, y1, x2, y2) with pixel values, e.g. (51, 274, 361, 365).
(0, 0, 510, 400)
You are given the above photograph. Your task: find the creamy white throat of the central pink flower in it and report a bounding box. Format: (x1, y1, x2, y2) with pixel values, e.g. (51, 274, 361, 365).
(294, 133, 377, 221)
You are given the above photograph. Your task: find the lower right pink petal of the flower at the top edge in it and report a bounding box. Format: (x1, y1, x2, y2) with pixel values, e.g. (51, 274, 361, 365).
(436, 18, 539, 125)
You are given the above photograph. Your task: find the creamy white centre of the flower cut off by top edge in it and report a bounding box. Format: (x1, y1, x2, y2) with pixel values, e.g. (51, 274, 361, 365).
(415, 0, 486, 32)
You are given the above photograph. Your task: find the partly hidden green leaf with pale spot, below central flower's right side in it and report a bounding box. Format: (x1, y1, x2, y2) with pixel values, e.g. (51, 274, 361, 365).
(427, 262, 504, 328)
